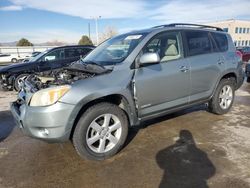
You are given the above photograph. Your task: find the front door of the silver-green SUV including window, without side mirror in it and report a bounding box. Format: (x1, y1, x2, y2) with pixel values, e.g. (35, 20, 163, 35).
(134, 32, 190, 118)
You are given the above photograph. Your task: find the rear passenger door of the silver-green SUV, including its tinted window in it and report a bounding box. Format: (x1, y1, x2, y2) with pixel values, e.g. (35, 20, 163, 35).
(184, 30, 225, 102)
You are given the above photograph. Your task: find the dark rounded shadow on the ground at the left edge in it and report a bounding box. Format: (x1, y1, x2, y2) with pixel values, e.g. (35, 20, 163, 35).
(0, 111, 15, 142)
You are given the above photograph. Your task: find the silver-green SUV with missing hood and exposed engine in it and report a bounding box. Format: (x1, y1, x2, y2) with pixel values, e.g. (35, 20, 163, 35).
(11, 24, 243, 160)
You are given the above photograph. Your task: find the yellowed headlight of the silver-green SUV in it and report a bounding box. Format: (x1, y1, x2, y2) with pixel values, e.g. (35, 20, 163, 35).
(30, 85, 71, 106)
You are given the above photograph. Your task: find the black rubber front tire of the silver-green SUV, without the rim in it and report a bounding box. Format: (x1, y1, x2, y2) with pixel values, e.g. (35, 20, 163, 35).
(73, 103, 128, 160)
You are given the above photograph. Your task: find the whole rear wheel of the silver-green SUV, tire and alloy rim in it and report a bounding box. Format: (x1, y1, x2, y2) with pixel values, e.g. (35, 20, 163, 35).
(208, 78, 236, 115)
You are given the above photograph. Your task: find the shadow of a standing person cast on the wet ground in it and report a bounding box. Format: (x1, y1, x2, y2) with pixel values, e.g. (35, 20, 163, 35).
(156, 130, 216, 188)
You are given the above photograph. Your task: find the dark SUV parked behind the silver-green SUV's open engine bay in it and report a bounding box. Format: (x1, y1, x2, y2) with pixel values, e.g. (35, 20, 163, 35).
(0, 45, 95, 91)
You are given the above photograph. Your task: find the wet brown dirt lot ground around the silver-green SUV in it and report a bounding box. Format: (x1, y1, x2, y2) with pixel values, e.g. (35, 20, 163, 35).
(0, 83, 250, 188)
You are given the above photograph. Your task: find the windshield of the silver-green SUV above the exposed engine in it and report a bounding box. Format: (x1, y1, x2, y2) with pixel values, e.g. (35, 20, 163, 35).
(83, 33, 146, 66)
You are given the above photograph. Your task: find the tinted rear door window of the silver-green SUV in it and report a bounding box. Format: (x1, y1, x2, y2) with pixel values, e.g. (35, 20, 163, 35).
(186, 31, 212, 56)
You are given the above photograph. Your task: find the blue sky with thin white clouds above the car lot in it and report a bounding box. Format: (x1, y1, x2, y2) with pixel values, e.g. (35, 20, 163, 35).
(0, 0, 250, 43)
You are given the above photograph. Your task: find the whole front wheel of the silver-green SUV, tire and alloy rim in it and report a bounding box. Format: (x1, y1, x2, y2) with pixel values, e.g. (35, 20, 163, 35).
(72, 102, 128, 160)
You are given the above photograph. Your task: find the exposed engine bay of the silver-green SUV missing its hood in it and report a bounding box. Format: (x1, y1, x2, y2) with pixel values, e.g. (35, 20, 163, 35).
(23, 60, 111, 92)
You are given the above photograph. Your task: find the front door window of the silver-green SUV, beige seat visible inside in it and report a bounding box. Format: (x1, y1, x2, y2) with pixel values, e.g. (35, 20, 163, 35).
(143, 32, 182, 62)
